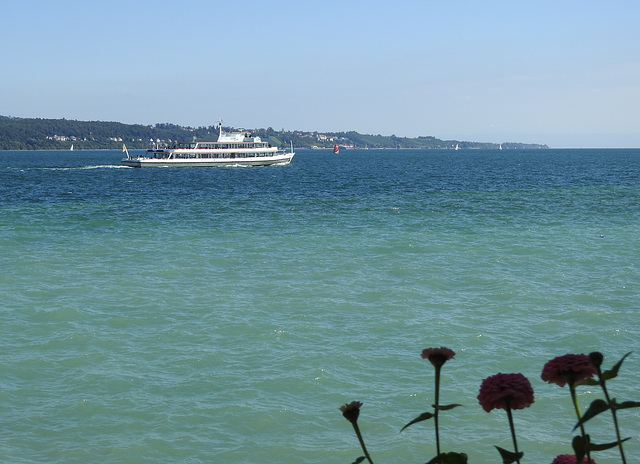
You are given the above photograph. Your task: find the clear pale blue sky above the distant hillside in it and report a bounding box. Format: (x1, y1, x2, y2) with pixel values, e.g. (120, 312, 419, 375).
(0, 0, 640, 148)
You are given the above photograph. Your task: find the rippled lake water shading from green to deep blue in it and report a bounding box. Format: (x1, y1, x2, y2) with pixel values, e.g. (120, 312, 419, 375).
(0, 150, 640, 464)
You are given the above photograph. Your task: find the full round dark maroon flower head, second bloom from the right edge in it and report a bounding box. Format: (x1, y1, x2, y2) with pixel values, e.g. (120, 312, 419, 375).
(478, 374, 533, 412)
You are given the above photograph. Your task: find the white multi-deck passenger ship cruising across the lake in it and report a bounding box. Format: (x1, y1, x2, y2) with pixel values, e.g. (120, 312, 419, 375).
(122, 123, 295, 168)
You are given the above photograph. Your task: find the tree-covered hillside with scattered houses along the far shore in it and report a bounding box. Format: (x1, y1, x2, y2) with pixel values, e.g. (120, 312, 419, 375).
(0, 116, 548, 150)
